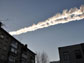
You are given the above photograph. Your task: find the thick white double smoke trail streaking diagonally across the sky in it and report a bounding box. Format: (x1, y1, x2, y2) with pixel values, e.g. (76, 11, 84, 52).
(9, 5, 84, 35)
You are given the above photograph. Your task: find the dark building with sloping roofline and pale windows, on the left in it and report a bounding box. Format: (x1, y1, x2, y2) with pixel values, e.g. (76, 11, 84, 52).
(0, 23, 36, 63)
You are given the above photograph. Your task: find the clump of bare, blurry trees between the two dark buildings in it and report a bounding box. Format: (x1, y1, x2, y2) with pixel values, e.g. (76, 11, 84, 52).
(36, 52, 49, 63)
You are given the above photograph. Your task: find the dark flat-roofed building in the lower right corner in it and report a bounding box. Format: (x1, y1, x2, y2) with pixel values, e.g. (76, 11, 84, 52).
(59, 43, 84, 63)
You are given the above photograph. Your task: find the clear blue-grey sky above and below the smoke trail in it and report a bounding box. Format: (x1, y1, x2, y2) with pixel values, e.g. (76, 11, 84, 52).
(0, 0, 84, 61)
